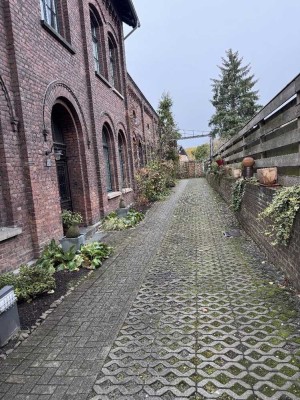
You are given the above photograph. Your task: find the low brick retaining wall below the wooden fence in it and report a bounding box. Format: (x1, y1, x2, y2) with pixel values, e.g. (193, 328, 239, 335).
(208, 175, 300, 290)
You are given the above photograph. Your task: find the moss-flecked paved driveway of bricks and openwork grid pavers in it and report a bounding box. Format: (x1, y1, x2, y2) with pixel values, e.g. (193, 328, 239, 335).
(0, 179, 300, 400)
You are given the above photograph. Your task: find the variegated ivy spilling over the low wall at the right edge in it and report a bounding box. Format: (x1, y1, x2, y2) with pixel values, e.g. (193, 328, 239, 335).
(259, 186, 300, 246)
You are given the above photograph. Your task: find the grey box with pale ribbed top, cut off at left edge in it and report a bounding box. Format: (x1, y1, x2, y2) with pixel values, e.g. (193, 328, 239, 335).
(0, 286, 20, 347)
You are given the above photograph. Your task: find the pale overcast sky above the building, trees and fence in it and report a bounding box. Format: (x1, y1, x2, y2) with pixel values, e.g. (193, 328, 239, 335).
(125, 0, 300, 147)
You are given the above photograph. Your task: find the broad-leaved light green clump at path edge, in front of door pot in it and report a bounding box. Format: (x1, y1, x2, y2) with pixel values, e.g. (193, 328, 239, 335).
(80, 242, 112, 269)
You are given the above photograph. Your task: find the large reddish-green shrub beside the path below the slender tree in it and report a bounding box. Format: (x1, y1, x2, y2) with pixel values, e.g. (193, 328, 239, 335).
(136, 161, 176, 203)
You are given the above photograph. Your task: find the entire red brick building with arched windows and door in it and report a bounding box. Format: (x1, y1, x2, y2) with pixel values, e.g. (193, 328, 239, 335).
(0, 0, 157, 271)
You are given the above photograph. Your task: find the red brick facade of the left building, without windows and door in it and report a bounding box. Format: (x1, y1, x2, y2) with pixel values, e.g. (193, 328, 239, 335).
(0, 0, 159, 271)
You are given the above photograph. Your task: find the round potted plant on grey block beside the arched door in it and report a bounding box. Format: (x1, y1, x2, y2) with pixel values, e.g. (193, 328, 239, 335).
(60, 210, 85, 252)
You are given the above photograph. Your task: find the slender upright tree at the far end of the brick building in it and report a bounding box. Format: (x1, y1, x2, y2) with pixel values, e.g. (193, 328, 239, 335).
(157, 93, 180, 160)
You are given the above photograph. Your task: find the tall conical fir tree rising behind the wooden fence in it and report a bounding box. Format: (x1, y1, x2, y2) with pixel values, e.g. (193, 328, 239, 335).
(209, 49, 261, 138)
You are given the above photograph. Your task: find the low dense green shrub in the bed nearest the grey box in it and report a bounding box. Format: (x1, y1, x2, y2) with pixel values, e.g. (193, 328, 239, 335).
(0, 265, 56, 300)
